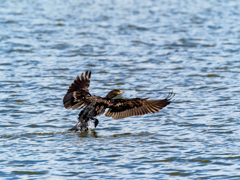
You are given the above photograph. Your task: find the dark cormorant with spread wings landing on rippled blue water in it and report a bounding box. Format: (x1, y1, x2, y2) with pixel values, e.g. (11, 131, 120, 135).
(63, 71, 175, 131)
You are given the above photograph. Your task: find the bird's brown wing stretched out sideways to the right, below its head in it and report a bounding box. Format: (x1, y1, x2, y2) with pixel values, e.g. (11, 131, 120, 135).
(105, 92, 175, 119)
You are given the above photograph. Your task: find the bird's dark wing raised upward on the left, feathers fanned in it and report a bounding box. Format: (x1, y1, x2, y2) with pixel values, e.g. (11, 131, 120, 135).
(63, 71, 92, 109)
